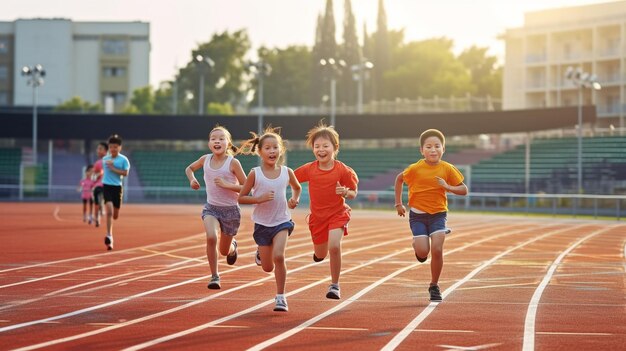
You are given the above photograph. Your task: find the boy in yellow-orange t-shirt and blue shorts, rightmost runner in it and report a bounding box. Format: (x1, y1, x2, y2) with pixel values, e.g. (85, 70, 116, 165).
(395, 129, 467, 302)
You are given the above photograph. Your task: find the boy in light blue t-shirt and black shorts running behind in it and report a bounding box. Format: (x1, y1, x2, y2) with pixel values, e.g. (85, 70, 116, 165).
(102, 134, 130, 250)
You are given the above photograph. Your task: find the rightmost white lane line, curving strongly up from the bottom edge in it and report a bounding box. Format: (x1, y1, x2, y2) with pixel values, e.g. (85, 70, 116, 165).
(522, 227, 612, 351)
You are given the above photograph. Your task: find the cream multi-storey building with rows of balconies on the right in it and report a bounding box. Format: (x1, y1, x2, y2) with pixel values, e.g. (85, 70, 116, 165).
(503, 1, 626, 127)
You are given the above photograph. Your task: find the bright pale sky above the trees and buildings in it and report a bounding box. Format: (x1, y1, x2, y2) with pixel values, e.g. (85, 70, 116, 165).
(0, 0, 611, 86)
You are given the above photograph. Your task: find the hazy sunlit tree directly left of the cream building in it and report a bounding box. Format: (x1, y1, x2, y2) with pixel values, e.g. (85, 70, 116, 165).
(459, 46, 502, 98)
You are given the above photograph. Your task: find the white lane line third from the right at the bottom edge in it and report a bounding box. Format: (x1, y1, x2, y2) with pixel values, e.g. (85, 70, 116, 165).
(248, 224, 566, 351)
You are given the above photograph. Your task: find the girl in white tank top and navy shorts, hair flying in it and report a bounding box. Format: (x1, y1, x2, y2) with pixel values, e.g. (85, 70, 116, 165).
(239, 128, 302, 312)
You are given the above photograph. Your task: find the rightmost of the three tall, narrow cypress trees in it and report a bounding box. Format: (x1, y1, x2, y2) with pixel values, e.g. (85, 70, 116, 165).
(373, 0, 391, 99)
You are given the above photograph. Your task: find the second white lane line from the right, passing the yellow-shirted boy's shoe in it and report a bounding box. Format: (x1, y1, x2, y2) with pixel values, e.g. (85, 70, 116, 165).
(382, 226, 580, 351)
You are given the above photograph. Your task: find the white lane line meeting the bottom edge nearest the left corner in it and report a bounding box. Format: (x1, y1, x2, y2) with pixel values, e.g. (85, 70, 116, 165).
(12, 232, 412, 351)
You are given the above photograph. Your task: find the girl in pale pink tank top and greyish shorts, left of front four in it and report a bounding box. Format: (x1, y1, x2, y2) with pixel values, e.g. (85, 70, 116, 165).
(185, 126, 246, 289)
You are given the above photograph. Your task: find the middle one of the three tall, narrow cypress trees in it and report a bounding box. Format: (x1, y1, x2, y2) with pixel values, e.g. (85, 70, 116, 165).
(338, 0, 361, 105)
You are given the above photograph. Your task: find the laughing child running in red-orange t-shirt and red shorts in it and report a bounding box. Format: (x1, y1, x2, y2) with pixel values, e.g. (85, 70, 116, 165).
(294, 124, 359, 299)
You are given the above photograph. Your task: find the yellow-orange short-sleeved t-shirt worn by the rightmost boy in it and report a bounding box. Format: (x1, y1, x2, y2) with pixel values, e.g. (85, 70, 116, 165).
(402, 159, 463, 214)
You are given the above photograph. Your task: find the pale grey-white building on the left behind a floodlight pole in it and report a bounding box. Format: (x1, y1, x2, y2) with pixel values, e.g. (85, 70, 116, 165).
(0, 19, 150, 110)
